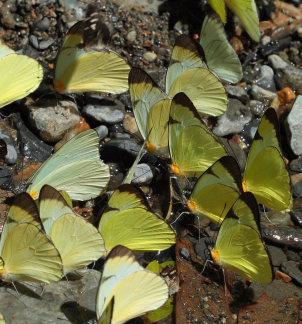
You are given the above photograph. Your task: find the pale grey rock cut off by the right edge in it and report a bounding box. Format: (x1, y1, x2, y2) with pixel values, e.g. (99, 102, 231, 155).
(285, 96, 302, 155)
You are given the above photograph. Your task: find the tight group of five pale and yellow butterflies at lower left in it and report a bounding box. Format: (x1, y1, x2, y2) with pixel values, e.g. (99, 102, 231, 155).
(0, 130, 176, 323)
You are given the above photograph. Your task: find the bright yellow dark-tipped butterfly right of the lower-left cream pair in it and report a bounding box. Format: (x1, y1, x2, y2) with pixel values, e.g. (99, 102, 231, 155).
(98, 184, 175, 251)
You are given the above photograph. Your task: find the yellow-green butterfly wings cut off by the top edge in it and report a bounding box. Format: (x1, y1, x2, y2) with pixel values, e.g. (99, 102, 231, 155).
(209, 0, 260, 42)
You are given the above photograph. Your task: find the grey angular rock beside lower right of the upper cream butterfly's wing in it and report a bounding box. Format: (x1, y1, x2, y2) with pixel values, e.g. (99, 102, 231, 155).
(213, 99, 252, 136)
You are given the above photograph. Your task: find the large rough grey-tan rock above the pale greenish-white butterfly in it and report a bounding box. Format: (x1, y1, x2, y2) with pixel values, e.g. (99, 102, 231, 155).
(28, 99, 80, 142)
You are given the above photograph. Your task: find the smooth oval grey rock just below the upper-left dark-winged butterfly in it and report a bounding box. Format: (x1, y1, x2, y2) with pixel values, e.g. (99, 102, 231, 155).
(83, 97, 125, 125)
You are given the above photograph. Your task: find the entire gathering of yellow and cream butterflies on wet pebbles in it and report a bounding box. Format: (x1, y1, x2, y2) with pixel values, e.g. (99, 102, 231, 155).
(0, 0, 286, 324)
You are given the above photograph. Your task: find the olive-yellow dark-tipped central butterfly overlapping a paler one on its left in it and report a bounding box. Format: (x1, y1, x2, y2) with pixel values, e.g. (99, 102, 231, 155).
(169, 93, 227, 177)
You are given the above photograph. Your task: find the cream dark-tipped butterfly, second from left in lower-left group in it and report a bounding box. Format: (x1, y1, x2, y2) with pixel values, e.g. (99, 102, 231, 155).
(39, 185, 105, 274)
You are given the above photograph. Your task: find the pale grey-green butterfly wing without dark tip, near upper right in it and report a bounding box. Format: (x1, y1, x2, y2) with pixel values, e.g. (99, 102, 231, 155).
(200, 14, 242, 83)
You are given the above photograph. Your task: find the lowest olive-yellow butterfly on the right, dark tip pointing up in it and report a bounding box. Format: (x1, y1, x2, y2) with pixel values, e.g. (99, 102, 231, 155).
(211, 193, 273, 283)
